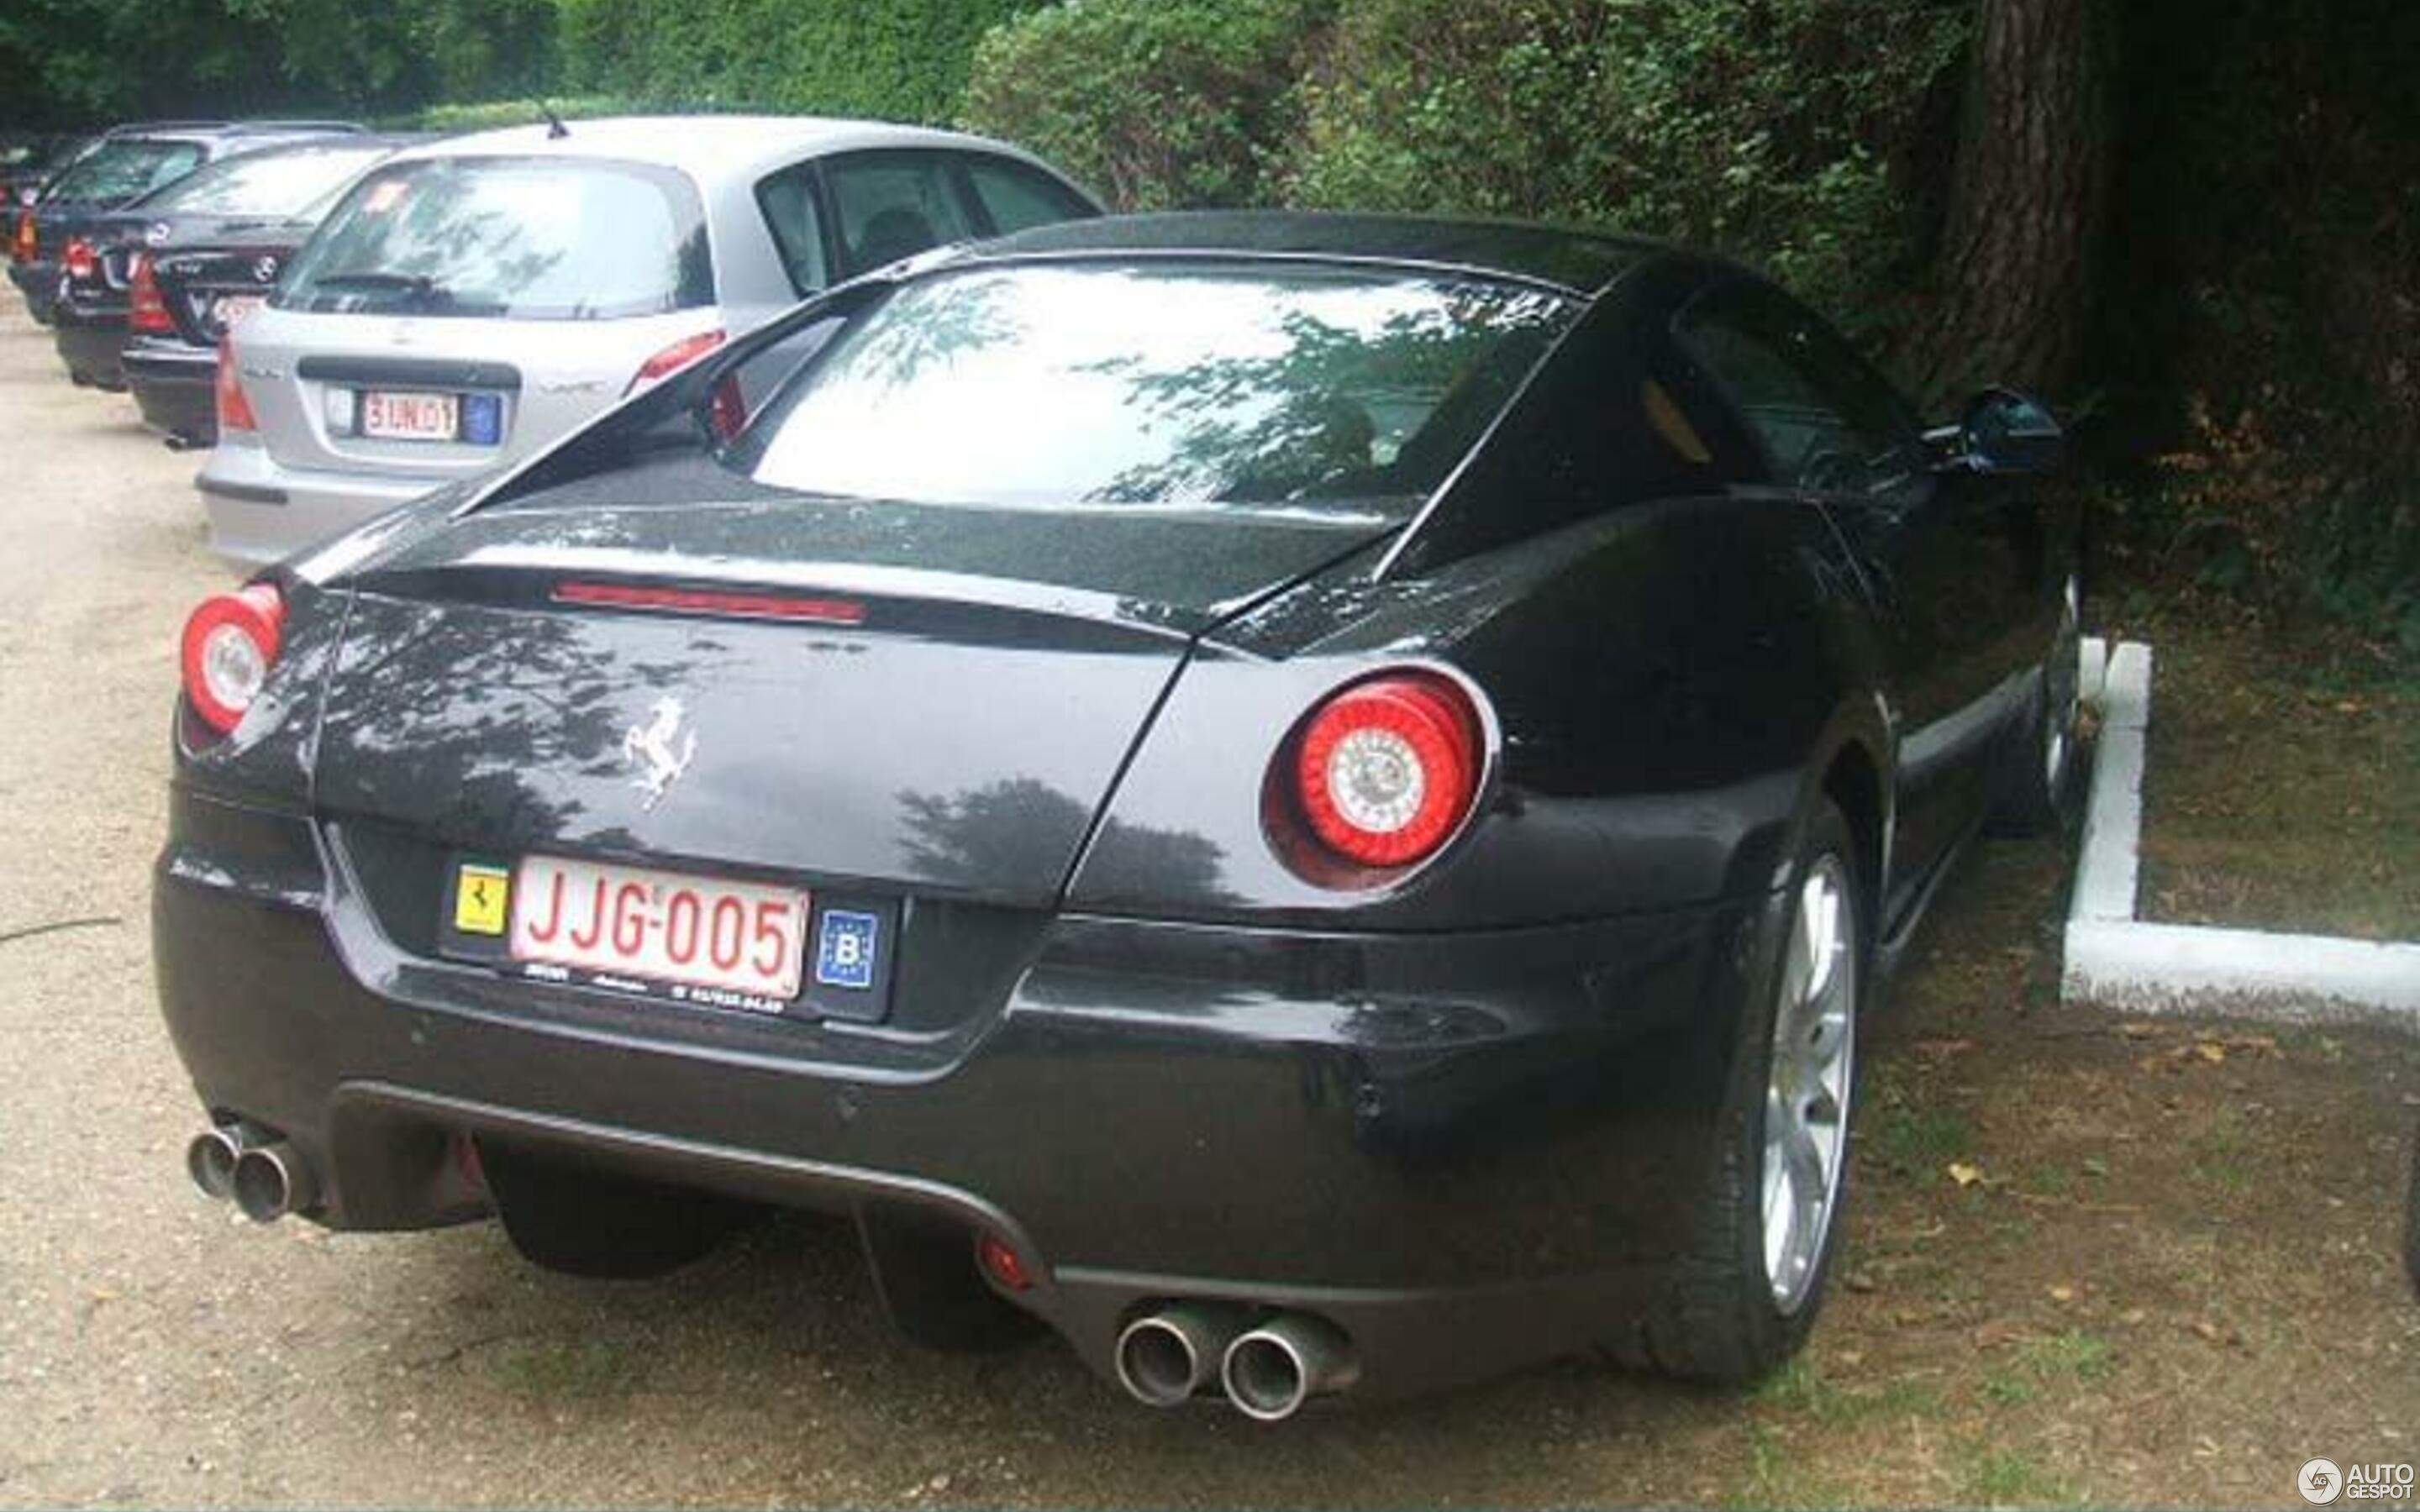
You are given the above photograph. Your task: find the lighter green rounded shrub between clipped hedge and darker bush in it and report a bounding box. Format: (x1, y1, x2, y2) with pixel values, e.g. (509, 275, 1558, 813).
(963, 0, 1334, 211)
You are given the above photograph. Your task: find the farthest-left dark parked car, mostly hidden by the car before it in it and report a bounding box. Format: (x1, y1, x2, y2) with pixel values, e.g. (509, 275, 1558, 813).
(8, 121, 360, 324)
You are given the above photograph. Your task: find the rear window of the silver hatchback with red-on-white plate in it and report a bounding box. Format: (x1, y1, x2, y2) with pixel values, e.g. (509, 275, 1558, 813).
(278, 157, 714, 319)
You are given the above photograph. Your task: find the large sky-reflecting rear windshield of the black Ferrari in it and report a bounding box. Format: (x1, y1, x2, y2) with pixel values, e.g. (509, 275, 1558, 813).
(726, 264, 1573, 513)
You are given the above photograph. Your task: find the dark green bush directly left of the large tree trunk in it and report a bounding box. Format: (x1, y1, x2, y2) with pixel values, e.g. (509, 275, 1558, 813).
(1287, 0, 1965, 339)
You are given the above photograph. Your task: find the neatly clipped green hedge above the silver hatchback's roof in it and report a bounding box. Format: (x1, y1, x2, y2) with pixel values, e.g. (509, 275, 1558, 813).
(561, 0, 1036, 123)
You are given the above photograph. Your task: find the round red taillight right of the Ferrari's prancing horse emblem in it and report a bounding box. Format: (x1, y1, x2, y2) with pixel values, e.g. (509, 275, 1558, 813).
(1295, 673, 1481, 866)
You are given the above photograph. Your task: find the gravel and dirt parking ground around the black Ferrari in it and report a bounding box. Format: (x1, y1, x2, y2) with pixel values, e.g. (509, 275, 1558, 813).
(0, 302, 2420, 1504)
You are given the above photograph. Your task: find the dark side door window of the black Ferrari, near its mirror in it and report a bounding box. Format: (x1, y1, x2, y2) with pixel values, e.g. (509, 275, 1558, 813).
(1677, 291, 1919, 494)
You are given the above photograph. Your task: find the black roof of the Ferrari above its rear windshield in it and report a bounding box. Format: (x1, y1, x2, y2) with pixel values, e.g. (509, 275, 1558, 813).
(963, 211, 1672, 295)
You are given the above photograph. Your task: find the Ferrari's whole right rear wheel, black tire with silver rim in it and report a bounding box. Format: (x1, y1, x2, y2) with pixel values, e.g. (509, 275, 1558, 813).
(1609, 801, 1868, 1383)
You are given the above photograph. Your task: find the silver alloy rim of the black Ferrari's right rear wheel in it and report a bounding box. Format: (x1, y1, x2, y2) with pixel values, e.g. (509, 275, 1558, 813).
(1760, 854, 1859, 1316)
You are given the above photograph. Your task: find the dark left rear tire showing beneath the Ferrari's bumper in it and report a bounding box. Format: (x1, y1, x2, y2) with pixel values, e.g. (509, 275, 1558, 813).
(479, 1139, 755, 1280)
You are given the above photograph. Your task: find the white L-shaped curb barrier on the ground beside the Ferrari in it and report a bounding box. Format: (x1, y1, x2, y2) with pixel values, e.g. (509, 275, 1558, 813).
(2060, 641, 2420, 1028)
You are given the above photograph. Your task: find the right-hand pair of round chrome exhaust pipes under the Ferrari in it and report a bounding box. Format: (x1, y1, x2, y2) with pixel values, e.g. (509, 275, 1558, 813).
(1118, 1301, 1360, 1422)
